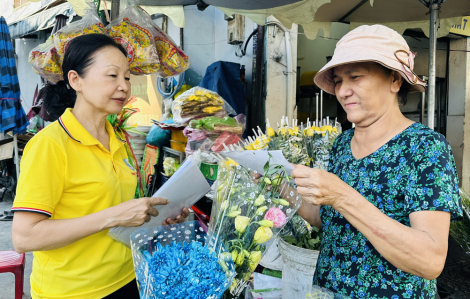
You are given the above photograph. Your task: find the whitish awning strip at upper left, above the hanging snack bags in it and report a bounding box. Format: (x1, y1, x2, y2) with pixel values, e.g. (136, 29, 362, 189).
(8, 3, 75, 39)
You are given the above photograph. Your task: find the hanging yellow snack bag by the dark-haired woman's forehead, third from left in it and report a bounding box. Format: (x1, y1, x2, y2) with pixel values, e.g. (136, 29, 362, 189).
(107, 0, 160, 75)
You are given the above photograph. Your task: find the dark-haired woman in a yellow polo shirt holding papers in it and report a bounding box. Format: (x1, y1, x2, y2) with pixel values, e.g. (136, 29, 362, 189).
(12, 34, 189, 299)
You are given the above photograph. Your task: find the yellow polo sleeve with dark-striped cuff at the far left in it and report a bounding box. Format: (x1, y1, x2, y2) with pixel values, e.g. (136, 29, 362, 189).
(12, 136, 66, 217)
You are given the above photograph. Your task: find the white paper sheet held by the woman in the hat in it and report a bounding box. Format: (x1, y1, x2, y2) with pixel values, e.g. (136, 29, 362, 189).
(220, 150, 294, 175)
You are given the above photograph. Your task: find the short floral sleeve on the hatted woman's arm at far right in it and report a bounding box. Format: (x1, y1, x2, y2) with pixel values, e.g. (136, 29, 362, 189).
(404, 133, 462, 220)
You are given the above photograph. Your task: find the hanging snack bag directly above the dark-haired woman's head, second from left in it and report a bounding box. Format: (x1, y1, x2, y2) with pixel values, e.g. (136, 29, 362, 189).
(53, 2, 106, 65)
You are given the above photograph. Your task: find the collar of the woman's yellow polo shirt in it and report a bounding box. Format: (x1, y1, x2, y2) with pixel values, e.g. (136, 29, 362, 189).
(57, 108, 126, 148)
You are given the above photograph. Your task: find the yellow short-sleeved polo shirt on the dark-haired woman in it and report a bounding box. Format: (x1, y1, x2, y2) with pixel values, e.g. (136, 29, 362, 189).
(12, 109, 137, 299)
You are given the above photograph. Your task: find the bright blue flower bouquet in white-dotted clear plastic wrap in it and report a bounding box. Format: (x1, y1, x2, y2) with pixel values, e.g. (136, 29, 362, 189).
(131, 221, 235, 299)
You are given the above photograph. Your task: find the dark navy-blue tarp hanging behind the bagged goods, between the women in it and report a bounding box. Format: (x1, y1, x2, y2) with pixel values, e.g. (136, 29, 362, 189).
(199, 61, 246, 114)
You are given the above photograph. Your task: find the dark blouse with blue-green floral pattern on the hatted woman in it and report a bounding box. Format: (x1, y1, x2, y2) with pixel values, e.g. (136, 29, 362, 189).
(314, 123, 462, 299)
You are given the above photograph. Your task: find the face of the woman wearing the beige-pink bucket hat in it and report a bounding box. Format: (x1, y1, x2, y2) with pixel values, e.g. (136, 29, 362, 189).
(333, 62, 402, 126)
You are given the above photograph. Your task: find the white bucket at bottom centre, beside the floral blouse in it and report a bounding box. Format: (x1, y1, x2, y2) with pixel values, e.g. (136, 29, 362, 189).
(279, 239, 320, 298)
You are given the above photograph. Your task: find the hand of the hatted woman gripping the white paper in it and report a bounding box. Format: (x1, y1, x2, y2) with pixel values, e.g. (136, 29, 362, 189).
(291, 165, 352, 208)
